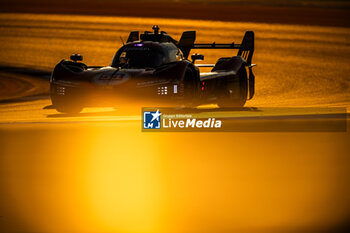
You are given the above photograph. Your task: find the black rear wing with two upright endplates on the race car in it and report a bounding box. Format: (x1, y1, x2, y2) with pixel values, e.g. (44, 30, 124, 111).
(178, 31, 254, 66)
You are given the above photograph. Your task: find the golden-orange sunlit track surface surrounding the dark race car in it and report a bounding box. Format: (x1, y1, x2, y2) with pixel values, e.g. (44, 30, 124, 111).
(0, 14, 350, 232)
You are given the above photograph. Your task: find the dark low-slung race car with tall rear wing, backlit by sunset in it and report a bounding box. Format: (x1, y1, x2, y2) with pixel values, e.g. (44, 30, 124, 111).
(50, 26, 255, 114)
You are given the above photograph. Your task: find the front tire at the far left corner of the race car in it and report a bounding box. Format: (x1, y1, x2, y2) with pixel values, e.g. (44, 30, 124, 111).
(50, 84, 84, 114)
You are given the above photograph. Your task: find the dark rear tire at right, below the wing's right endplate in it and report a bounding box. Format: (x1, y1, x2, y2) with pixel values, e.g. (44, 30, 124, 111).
(218, 67, 248, 108)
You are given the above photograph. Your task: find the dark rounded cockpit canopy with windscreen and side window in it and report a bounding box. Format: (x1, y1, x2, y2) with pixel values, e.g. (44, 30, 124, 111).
(111, 41, 184, 68)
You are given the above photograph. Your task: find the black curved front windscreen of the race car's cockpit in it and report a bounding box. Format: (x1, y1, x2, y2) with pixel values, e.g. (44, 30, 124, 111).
(112, 46, 164, 68)
